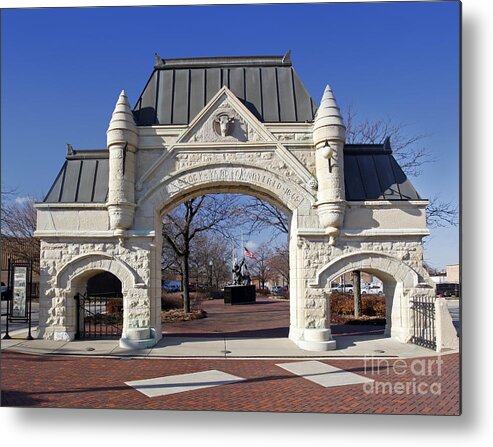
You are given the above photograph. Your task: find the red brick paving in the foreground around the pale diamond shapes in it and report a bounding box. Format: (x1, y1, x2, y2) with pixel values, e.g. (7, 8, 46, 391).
(1, 351, 460, 415)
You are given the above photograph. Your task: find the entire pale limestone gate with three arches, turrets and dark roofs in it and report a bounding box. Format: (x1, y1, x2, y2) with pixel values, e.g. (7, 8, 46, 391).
(36, 56, 452, 350)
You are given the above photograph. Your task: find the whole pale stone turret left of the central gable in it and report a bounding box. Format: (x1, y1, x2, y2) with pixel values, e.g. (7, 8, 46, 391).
(106, 90, 139, 233)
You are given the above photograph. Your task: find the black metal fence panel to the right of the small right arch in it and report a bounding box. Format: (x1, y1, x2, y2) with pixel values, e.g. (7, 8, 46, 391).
(411, 296, 437, 349)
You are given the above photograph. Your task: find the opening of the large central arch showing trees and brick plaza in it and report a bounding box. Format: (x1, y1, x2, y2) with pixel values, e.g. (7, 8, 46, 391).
(160, 190, 292, 344)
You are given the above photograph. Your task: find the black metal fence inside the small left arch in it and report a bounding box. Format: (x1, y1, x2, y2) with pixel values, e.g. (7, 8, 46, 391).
(75, 293, 123, 340)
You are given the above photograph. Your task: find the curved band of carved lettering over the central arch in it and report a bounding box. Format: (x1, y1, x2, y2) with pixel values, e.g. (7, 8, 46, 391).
(167, 168, 303, 206)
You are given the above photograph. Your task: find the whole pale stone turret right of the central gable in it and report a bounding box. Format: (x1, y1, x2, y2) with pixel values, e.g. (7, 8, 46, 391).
(313, 86, 346, 241)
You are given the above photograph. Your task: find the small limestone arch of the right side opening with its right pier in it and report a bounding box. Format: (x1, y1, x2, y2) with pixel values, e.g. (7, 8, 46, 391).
(310, 250, 421, 342)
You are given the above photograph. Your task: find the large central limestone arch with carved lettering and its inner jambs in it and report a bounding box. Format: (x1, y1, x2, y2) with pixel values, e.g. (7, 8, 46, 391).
(136, 164, 318, 338)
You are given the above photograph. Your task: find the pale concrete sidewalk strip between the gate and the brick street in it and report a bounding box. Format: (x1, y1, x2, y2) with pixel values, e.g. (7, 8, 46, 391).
(1, 331, 452, 359)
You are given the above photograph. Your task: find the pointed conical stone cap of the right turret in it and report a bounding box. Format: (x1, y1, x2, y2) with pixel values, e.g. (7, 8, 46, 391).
(313, 85, 346, 144)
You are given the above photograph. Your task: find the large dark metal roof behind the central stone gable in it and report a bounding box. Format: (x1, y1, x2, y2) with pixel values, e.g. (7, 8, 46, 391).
(134, 53, 317, 126)
